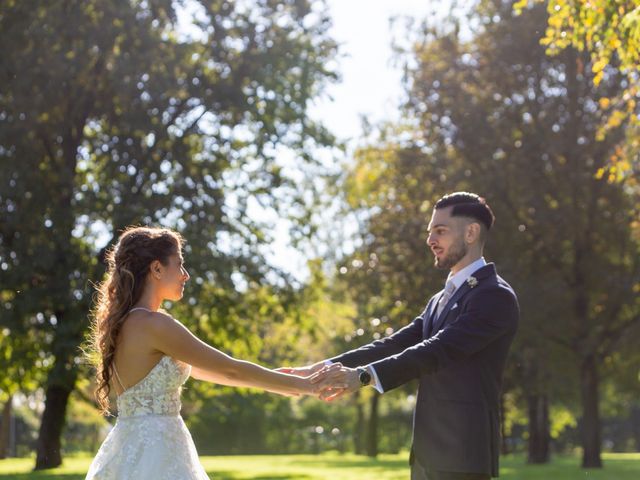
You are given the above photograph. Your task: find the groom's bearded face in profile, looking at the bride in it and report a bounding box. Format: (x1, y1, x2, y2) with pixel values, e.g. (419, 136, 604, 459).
(427, 207, 468, 270)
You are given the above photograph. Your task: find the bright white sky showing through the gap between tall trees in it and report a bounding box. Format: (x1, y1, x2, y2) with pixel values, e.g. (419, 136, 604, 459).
(269, 0, 440, 280)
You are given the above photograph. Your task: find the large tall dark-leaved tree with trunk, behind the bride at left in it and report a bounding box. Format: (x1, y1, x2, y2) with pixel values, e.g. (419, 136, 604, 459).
(0, 0, 335, 468)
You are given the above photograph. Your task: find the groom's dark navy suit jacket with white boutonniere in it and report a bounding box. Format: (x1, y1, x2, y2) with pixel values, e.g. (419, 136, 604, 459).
(331, 263, 520, 476)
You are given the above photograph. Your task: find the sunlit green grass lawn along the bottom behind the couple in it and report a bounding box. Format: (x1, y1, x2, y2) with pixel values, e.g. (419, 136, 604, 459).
(0, 453, 640, 480)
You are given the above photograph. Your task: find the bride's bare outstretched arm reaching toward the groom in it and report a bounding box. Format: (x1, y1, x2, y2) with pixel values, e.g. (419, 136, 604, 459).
(147, 312, 320, 395)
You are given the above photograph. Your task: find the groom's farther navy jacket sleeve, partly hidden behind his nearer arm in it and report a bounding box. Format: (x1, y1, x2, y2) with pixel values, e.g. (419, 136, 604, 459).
(330, 302, 431, 368)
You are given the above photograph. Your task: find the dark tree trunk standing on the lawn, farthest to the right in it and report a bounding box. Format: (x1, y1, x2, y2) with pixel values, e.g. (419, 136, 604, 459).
(580, 355, 602, 468)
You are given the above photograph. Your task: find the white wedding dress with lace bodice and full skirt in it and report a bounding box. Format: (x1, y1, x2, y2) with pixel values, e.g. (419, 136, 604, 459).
(85, 356, 209, 480)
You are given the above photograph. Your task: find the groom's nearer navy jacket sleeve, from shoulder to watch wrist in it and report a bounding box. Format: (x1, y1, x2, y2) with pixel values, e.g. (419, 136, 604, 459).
(372, 287, 518, 392)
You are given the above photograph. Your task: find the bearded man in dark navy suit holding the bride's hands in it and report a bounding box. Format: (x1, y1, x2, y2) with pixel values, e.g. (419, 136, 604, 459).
(289, 192, 519, 480)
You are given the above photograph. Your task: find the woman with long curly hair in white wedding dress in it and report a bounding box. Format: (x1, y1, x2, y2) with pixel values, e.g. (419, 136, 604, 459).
(86, 227, 328, 480)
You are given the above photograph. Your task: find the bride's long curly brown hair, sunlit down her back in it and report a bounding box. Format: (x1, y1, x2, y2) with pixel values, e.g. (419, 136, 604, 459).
(89, 227, 184, 414)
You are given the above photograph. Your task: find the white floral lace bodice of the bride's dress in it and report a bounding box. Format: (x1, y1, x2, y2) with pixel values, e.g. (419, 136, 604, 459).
(117, 356, 191, 418)
